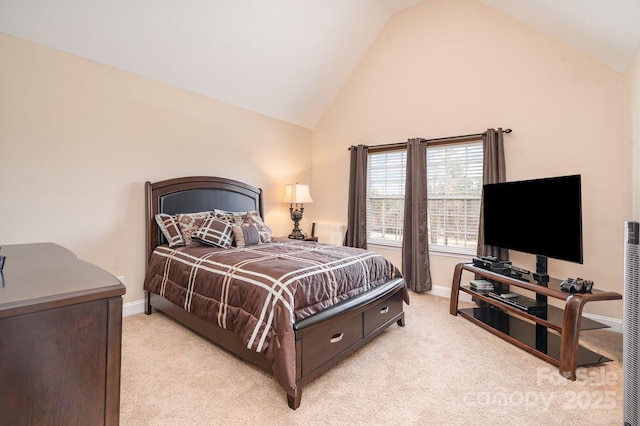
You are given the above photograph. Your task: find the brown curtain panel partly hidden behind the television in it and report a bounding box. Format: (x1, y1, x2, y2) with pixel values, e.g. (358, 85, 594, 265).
(478, 128, 509, 260)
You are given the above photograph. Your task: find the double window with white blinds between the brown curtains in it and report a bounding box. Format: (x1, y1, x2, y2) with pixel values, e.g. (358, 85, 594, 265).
(367, 140, 483, 253)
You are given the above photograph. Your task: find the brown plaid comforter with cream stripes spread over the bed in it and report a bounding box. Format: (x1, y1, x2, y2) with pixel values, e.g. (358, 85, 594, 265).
(144, 239, 408, 390)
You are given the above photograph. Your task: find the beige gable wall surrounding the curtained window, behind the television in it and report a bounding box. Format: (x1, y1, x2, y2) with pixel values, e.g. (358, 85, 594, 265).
(312, 0, 628, 318)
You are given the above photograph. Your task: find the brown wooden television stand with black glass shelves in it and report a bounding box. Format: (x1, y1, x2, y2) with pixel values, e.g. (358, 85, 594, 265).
(449, 263, 622, 380)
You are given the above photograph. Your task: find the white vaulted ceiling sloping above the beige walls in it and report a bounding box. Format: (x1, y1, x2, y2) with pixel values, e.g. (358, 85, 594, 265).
(0, 0, 640, 128)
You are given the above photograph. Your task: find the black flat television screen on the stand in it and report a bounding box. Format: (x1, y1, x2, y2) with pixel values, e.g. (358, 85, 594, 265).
(483, 175, 582, 263)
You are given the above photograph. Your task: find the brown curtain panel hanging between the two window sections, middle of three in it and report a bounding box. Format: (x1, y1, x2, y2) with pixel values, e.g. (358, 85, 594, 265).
(402, 139, 432, 293)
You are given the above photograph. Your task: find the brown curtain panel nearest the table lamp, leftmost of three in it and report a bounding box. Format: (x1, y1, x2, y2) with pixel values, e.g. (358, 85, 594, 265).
(345, 145, 369, 249)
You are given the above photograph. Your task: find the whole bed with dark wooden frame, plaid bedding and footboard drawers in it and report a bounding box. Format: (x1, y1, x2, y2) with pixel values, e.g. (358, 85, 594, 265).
(144, 176, 409, 409)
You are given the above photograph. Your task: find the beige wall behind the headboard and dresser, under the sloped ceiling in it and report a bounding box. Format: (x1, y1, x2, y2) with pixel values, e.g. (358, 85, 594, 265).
(0, 34, 313, 302)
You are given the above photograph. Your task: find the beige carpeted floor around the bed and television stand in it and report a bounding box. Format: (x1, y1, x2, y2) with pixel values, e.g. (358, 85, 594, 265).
(120, 293, 623, 426)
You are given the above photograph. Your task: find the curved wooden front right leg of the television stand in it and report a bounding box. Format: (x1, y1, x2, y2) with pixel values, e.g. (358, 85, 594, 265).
(559, 294, 584, 380)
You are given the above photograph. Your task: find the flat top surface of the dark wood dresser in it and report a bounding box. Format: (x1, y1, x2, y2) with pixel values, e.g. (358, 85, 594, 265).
(0, 243, 126, 318)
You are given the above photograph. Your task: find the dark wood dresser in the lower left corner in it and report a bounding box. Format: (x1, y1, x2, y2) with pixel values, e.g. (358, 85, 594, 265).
(0, 243, 125, 425)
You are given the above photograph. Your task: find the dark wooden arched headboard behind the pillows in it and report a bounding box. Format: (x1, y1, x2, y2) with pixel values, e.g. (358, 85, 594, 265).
(145, 176, 264, 260)
